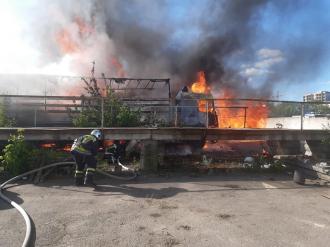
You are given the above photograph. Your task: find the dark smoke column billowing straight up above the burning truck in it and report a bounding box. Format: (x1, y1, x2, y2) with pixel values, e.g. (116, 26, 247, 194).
(96, 0, 267, 95)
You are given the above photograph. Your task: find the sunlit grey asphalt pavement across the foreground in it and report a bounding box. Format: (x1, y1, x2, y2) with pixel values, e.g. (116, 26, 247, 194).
(0, 174, 330, 247)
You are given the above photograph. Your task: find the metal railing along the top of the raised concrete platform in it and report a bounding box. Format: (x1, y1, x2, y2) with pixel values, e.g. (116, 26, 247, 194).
(0, 95, 330, 130)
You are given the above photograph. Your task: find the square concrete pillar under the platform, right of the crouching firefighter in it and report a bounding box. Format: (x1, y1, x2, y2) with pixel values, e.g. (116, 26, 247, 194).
(140, 140, 164, 172)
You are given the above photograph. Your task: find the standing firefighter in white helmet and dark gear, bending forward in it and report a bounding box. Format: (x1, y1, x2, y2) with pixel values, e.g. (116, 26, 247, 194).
(71, 130, 102, 186)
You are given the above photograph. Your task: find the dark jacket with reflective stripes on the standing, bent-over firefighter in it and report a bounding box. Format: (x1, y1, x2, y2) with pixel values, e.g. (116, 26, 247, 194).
(71, 135, 99, 156)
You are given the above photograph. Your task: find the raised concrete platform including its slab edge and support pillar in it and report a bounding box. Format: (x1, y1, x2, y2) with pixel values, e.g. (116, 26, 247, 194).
(0, 128, 330, 171)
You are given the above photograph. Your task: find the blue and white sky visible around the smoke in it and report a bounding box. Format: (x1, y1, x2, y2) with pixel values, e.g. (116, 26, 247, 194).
(0, 0, 330, 100)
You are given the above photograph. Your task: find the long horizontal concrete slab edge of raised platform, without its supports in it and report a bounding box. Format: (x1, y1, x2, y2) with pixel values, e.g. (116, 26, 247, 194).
(0, 128, 328, 141)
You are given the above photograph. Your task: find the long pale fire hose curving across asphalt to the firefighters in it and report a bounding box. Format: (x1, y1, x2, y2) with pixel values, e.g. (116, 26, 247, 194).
(0, 160, 137, 247)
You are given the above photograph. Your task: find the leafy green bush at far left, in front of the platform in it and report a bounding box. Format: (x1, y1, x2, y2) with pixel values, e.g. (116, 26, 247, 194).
(0, 130, 32, 176)
